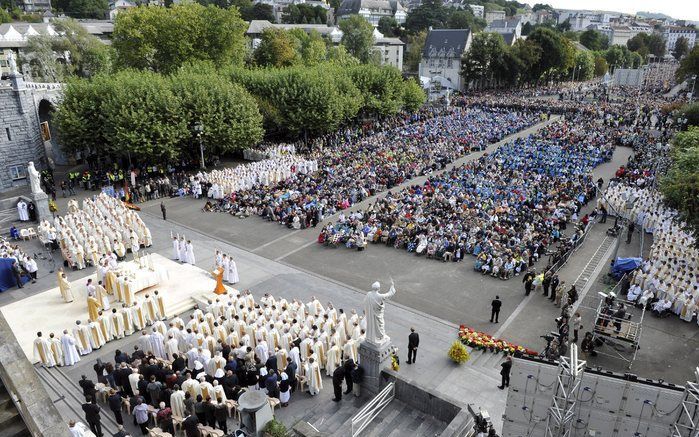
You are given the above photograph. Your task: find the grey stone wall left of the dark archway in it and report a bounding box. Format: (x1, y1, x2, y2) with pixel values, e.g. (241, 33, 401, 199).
(0, 82, 46, 191)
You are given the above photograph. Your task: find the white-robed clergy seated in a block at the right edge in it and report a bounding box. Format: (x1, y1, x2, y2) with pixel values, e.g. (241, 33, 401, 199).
(606, 184, 699, 323)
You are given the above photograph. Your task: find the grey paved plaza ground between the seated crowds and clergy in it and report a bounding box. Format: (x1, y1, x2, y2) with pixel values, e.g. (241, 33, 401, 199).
(0, 116, 699, 431)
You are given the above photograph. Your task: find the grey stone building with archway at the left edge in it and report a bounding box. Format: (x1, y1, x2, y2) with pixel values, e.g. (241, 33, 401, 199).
(0, 65, 63, 191)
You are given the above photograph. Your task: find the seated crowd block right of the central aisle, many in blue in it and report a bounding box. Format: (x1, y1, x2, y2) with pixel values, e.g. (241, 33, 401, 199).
(319, 117, 614, 279)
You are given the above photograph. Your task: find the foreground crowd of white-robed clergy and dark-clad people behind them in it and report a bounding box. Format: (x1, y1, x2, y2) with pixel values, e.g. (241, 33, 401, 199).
(35, 291, 365, 435)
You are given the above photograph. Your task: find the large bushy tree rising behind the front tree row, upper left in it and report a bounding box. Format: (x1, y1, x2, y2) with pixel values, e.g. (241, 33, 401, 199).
(112, 3, 247, 73)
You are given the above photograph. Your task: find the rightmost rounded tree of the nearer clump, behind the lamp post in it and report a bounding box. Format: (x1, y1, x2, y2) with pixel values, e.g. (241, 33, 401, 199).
(170, 66, 264, 154)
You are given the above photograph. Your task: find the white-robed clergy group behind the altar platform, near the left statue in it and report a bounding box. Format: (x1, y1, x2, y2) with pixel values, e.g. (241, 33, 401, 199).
(38, 193, 153, 269)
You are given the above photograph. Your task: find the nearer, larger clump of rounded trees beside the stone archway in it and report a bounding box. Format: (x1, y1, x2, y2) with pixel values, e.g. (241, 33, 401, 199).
(54, 68, 263, 160)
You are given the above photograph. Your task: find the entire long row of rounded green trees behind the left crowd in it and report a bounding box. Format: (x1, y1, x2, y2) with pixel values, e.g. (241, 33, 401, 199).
(55, 62, 425, 155)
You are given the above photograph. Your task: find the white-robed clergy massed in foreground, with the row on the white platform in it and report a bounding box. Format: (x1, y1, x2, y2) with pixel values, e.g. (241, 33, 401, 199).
(35, 291, 366, 394)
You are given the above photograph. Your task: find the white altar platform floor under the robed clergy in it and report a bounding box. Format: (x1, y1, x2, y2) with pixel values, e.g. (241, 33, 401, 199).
(0, 254, 233, 362)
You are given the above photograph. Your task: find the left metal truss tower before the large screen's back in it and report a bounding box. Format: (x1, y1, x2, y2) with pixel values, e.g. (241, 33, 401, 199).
(546, 344, 585, 437)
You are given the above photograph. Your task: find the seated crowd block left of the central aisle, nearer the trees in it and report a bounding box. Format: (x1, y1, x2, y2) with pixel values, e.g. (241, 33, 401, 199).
(194, 108, 539, 229)
